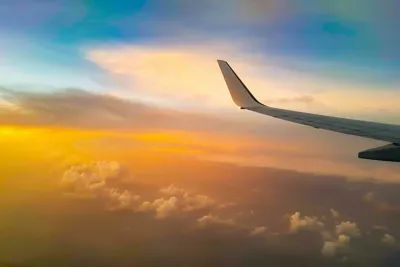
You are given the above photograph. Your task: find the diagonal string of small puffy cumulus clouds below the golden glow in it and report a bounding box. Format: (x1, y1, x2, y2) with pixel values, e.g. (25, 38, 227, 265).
(57, 162, 396, 260)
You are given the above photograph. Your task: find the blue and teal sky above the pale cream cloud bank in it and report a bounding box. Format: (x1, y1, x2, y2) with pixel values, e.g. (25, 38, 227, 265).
(0, 0, 400, 95)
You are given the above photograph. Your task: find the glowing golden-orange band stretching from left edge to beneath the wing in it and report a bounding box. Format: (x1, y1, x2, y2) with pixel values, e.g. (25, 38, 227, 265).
(0, 122, 396, 188)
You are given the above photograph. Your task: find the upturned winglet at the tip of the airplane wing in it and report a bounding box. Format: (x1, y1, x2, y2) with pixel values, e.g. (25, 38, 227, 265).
(217, 60, 263, 109)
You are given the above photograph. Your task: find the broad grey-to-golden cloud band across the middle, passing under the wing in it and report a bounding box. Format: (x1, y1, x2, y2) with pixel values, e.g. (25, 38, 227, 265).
(0, 90, 397, 184)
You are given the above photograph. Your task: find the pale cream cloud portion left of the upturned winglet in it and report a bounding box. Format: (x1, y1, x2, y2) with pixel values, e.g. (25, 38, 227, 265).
(87, 44, 253, 107)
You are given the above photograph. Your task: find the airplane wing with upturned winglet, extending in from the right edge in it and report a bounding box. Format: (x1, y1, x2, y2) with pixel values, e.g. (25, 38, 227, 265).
(218, 60, 400, 162)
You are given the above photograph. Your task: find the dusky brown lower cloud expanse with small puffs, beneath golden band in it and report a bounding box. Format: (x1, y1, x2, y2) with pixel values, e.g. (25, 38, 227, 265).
(10, 156, 399, 266)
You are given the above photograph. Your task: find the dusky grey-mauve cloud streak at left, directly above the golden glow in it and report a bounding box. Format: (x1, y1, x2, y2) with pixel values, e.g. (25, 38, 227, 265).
(0, 89, 219, 129)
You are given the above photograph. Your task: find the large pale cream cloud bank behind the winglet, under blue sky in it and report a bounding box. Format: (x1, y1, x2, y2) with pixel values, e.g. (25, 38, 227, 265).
(86, 41, 399, 121)
